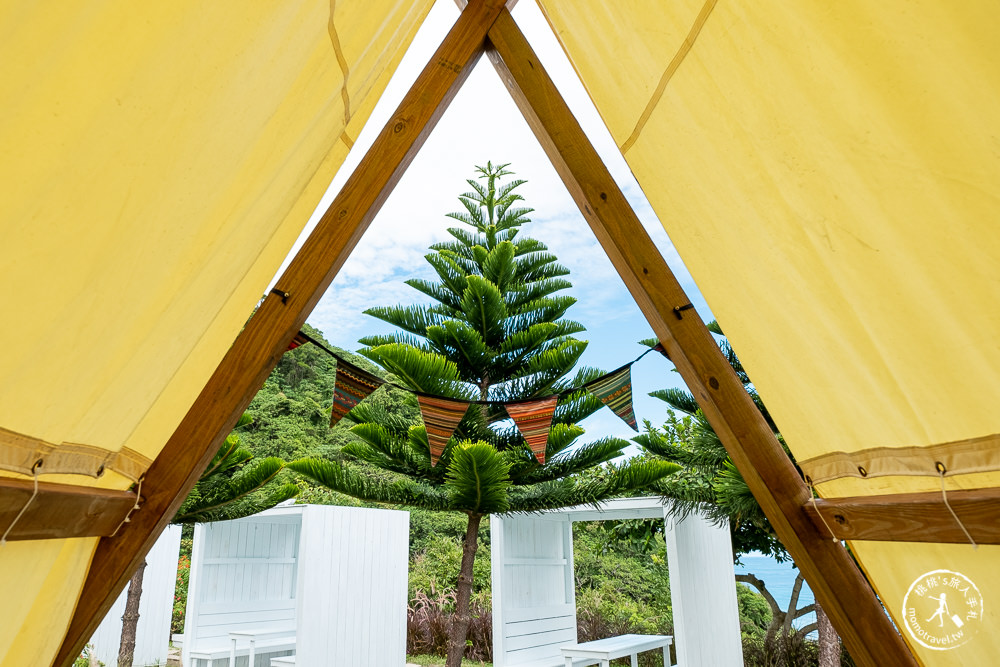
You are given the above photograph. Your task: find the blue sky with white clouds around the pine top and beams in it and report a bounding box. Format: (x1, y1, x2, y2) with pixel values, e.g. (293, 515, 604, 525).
(270, 0, 711, 448)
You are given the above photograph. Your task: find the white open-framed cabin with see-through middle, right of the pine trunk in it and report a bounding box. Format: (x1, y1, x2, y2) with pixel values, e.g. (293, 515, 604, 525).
(490, 498, 743, 667)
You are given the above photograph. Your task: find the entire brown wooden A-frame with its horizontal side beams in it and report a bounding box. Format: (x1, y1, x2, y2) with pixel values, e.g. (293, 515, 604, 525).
(52, 0, 1000, 666)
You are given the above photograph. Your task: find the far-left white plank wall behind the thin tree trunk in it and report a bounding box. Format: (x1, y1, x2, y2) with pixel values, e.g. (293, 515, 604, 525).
(87, 526, 181, 667)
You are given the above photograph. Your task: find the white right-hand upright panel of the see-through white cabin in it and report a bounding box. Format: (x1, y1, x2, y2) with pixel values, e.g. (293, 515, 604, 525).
(664, 508, 743, 667)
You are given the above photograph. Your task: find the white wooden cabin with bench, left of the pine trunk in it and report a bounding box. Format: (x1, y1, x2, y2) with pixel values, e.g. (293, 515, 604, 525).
(181, 505, 409, 667)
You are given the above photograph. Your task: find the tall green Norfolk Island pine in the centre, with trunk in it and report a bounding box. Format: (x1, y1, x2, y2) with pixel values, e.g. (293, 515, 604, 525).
(289, 162, 678, 667)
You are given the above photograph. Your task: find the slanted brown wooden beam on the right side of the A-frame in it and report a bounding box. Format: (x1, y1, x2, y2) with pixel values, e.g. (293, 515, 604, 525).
(489, 12, 916, 667)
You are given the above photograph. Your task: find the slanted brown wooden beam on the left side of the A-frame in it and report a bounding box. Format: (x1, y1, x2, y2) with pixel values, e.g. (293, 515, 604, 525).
(55, 0, 503, 667)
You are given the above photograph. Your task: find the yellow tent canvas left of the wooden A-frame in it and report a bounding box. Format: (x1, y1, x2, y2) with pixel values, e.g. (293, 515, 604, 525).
(0, 0, 431, 667)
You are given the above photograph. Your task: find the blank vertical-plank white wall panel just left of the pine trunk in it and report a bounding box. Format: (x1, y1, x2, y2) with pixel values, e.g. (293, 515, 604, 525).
(295, 505, 410, 667)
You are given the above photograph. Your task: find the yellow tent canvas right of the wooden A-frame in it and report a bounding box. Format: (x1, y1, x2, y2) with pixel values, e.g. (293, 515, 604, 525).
(540, 0, 1000, 664)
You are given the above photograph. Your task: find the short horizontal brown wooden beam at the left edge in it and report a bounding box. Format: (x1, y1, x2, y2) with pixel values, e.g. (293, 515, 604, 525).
(0, 477, 135, 541)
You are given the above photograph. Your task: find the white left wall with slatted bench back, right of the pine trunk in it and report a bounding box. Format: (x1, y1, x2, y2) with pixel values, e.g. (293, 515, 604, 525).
(490, 515, 576, 667)
